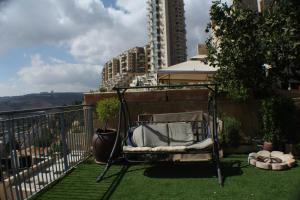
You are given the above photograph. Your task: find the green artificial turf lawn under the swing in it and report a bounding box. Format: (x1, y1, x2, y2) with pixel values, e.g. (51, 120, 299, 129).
(32, 156, 300, 200)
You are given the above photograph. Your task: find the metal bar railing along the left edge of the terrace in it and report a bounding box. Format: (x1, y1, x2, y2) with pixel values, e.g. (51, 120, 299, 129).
(0, 106, 93, 200)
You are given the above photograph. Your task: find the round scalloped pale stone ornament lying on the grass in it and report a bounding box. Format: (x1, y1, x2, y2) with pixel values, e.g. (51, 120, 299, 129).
(248, 150, 296, 171)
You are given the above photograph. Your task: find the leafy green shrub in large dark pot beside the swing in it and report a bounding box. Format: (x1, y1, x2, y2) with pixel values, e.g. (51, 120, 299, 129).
(92, 98, 120, 163)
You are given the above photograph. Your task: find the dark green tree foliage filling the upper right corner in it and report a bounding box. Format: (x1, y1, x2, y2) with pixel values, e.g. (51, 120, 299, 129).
(206, 0, 300, 100)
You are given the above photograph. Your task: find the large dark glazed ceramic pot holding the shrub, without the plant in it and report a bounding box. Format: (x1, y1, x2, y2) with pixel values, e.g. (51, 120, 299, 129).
(92, 129, 120, 163)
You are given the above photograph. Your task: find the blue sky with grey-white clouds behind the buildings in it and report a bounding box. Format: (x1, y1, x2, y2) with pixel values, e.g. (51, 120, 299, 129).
(0, 0, 211, 96)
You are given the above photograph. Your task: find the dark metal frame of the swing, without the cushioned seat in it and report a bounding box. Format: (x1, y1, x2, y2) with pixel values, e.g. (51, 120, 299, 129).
(97, 84, 223, 186)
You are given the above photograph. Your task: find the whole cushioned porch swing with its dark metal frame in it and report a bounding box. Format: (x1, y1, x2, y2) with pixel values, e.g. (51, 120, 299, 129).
(97, 84, 223, 185)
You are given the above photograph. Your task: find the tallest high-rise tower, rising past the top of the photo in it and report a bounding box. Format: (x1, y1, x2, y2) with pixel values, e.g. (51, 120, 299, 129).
(147, 0, 187, 72)
